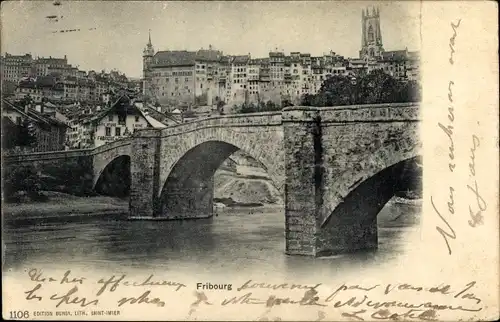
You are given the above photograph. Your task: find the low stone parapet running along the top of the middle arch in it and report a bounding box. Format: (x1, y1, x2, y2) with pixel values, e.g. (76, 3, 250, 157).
(157, 112, 281, 137)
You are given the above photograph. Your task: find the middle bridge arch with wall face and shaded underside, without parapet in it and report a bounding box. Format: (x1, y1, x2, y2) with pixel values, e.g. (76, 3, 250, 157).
(157, 115, 285, 218)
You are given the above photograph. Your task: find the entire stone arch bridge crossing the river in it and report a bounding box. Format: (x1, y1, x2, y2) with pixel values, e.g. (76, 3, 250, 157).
(4, 103, 421, 256)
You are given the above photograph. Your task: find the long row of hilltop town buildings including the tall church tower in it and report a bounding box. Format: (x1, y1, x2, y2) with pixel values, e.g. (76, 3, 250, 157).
(143, 8, 419, 110)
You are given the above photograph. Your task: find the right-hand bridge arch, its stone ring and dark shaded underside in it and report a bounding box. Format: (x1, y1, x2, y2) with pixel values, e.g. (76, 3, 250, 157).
(316, 135, 423, 256)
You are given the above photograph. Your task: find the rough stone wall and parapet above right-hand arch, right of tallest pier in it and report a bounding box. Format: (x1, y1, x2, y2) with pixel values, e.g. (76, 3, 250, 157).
(319, 103, 421, 224)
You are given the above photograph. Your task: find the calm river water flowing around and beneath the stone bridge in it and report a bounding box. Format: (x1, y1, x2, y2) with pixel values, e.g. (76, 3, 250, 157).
(4, 203, 420, 275)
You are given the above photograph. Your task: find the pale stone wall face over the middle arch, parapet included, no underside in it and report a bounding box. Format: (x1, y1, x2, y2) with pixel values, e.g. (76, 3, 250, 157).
(156, 112, 285, 195)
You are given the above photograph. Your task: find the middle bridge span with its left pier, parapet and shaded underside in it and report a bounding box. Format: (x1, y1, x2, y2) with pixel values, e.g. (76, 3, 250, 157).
(130, 113, 284, 219)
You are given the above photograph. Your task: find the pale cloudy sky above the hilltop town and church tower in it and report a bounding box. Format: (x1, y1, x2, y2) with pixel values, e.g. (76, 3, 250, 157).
(1, 0, 420, 77)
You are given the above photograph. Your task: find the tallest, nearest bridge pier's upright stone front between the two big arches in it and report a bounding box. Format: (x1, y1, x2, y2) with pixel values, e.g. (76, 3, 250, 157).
(283, 107, 322, 256)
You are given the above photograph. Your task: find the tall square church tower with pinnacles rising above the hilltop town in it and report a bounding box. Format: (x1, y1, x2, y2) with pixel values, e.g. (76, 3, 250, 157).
(359, 7, 384, 60)
